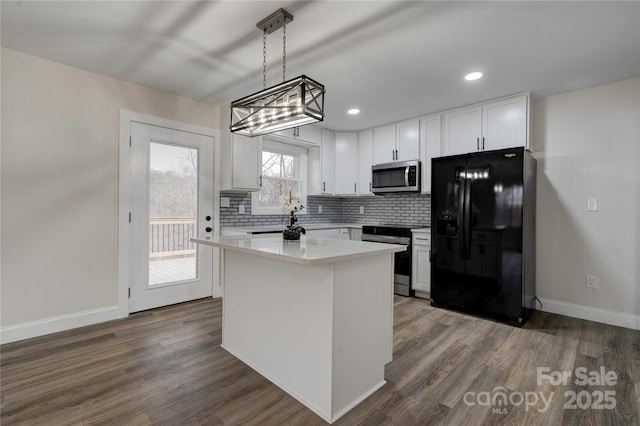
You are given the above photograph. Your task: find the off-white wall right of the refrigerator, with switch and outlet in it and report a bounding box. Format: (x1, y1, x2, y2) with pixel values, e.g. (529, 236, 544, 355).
(531, 79, 640, 328)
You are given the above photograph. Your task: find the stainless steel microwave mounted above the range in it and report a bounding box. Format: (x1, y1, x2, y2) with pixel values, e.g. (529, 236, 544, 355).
(371, 160, 420, 194)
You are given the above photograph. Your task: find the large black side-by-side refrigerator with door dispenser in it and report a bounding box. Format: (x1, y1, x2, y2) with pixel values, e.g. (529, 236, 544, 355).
(431, 148, 536, 326)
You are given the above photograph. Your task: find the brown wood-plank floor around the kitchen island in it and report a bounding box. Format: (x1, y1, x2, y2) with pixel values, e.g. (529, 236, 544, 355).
(0, 296, 640, 426)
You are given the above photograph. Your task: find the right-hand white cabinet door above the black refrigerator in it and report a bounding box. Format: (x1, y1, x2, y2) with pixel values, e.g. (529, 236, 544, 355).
(481, 95, 529, 150)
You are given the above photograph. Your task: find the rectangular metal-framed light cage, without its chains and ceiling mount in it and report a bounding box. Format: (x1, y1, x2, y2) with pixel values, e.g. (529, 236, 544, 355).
(230, 75, 325, 137)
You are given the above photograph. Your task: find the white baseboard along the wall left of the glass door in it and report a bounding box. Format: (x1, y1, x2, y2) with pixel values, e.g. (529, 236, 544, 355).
(0, 306, 129, 344)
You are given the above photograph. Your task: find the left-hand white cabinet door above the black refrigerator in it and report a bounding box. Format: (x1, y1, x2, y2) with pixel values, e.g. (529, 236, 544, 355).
(443, 105, 482, 155)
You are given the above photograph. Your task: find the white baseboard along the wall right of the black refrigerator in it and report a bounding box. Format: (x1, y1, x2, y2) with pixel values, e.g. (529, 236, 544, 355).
(540, 298, 640, 330)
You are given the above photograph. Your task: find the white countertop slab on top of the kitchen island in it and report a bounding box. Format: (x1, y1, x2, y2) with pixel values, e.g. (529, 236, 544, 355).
(191, 234, 406, 265)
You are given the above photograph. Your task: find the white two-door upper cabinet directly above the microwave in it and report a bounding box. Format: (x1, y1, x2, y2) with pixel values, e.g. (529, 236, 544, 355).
(373, 119, 420, 164)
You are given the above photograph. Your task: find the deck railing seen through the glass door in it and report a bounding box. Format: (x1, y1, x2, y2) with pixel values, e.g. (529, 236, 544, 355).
(149, 217, 196, 258)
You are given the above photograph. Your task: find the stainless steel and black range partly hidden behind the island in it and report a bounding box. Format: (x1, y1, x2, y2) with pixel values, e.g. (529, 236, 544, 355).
(362, 225, 420, 296)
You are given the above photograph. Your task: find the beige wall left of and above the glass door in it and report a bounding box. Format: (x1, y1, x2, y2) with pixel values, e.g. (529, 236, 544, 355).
(0, 48, 219, 327)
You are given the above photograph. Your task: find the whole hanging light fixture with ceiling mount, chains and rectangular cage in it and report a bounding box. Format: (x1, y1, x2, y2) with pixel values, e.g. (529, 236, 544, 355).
(230, 9, 325, 137)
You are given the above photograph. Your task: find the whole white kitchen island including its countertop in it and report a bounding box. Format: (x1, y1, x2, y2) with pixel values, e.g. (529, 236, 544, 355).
(192, 235, 405, 423)
